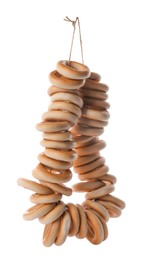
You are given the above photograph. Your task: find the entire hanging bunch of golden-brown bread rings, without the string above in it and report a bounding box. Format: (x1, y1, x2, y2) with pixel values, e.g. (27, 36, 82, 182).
(18, 61, 125, 246)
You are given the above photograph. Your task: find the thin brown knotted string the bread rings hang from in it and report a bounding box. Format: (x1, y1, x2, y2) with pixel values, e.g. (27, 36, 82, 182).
(64, 16, 84, 64)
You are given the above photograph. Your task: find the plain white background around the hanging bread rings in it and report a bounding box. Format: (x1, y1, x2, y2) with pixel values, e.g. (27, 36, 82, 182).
(0, 0, 152, 260)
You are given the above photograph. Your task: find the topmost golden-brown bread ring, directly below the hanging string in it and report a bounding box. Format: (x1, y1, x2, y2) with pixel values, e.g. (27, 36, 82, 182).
(57, 60, 90, 79)
